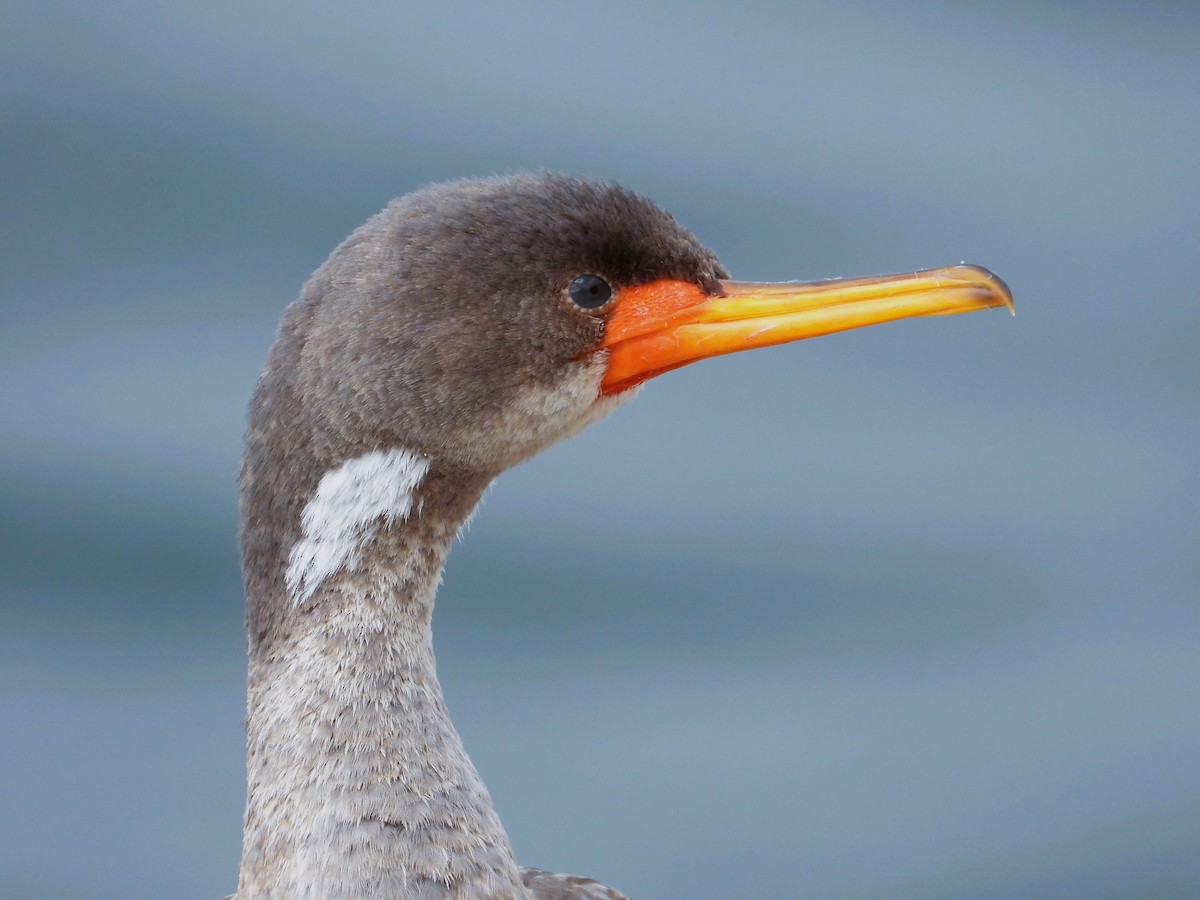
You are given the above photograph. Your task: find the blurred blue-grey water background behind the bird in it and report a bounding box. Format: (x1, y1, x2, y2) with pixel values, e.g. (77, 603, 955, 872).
(0, 0, 1200, 900)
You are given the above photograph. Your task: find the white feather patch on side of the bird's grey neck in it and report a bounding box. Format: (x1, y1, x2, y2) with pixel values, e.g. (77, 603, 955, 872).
(284, 448, 430, 605)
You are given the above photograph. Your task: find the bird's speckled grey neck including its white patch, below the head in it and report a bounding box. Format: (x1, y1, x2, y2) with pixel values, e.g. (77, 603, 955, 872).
(239, 451, 526, 898)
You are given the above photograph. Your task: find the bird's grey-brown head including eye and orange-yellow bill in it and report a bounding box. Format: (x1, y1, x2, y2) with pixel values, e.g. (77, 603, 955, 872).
(278, 174, 1010, 473)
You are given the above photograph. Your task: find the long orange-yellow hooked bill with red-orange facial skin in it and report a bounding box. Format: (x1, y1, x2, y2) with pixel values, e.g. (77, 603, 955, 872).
(600, 265, 1013, 395)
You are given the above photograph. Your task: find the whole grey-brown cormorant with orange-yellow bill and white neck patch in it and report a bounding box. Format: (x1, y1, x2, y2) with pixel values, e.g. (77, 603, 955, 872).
(231, 175, 1009, 900)
